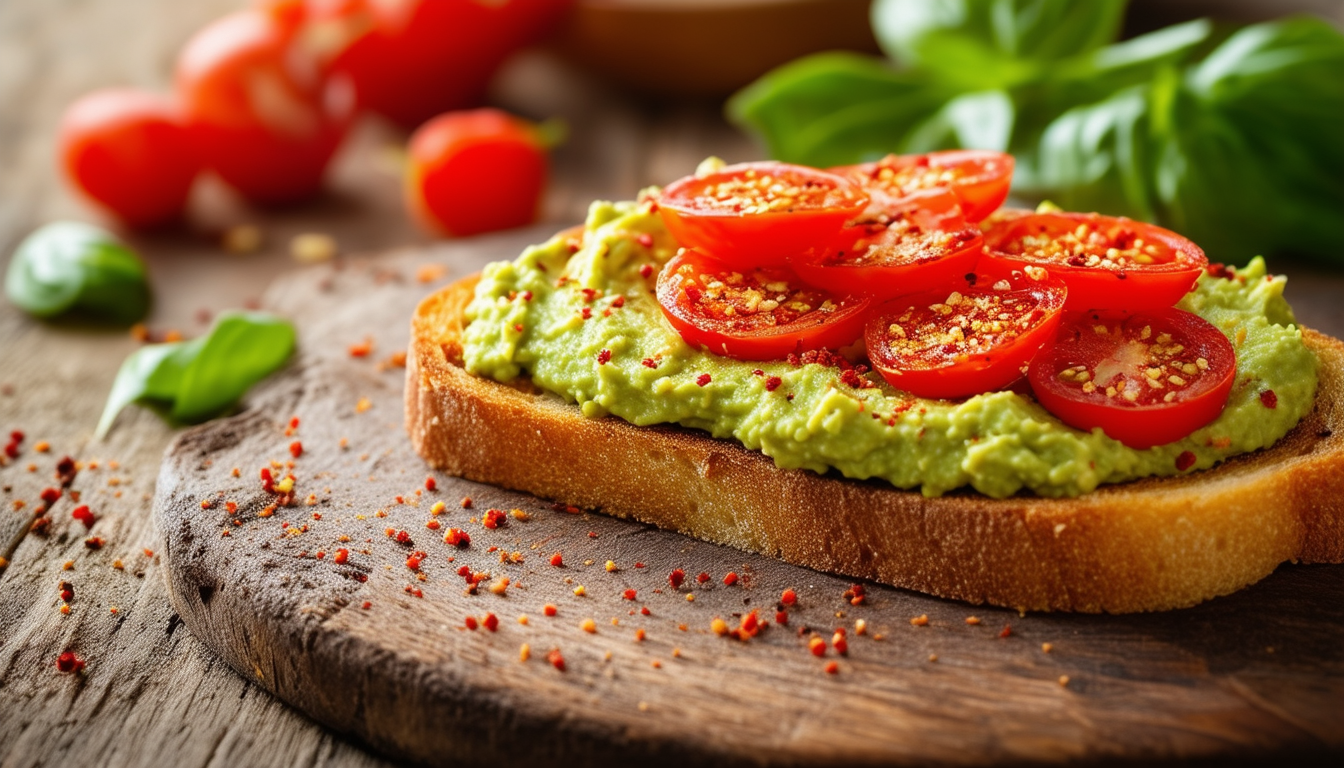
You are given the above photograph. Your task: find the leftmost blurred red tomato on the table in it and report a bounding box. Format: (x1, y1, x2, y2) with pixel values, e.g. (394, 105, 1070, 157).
(56, 89, 200, 227)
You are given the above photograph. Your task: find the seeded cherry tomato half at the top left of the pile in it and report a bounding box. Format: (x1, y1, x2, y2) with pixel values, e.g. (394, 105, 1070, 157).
(659, 163, 868, 268)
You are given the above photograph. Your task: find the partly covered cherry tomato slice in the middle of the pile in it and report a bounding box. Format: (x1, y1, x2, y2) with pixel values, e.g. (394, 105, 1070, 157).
(793, 190, 982, 299)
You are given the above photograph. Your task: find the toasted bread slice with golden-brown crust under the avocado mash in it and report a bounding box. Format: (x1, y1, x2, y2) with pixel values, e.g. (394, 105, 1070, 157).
(406, 277, 1344, 613)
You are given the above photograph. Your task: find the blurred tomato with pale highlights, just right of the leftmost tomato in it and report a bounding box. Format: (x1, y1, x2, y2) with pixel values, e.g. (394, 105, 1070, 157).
(177, 8, 353, 203)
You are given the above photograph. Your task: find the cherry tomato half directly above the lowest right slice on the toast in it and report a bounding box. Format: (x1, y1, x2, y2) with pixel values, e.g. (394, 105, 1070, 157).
(985, 213, 1208, 311)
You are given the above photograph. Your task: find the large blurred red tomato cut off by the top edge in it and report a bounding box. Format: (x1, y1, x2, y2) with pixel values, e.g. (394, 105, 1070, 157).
(335, 0, 573, 129)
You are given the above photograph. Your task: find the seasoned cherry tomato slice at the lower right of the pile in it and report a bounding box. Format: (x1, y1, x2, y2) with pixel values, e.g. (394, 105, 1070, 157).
(1028, 309, 1236, 449)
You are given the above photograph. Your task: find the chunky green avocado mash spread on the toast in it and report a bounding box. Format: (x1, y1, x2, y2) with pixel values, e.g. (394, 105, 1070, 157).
(464, 196, 1317, 498)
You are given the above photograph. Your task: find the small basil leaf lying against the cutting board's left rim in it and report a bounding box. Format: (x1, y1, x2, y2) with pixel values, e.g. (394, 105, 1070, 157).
(95, 312, 294, 438)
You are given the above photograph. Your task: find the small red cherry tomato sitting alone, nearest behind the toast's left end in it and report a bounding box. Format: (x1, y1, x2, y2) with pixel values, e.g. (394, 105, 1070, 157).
(406, 109, 547, 235)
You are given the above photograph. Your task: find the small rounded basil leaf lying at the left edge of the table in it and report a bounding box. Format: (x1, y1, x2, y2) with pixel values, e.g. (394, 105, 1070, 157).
(5, 222, 149, 325)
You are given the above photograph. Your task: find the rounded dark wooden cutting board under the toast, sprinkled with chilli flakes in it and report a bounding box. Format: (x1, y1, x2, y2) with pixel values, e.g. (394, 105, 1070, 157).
(155, 230, 1344, 764)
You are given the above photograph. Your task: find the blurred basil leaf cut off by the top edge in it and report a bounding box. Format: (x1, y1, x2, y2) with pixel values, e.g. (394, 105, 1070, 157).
(871, 0, 1126, 77)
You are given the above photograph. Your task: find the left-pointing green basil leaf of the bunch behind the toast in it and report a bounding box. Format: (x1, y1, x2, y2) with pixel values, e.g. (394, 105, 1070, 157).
(726, 54, 957, 168)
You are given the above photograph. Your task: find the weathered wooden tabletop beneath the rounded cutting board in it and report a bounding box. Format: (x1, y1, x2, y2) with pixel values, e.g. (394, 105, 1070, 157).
(0, 0, 1344, 767)
